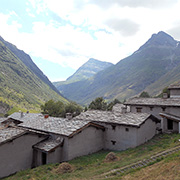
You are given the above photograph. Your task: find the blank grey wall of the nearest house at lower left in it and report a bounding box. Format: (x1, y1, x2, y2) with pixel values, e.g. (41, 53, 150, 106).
(0, 134, 44, 178)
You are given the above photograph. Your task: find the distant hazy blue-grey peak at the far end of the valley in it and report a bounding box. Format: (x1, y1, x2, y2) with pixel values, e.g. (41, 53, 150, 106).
(53, 58, 113, 93)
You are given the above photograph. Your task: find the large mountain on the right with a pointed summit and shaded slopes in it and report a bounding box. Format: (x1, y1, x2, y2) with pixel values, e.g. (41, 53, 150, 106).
(53, 31, 180, 104)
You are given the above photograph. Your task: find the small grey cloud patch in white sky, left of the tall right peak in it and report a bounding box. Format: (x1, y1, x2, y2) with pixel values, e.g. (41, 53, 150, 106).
(106, 18, 139, 36)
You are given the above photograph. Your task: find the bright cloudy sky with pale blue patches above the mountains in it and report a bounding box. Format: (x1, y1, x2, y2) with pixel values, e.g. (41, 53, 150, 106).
(0, 0, 180, 82)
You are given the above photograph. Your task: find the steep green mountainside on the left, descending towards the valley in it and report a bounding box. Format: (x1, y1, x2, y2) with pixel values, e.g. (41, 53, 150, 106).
(0, 37, 67, 109)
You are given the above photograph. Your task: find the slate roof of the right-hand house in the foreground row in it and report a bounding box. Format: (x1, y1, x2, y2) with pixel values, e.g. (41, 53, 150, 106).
(74, 110, 151, 127)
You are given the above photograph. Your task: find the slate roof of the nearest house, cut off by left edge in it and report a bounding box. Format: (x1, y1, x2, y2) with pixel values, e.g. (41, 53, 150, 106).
(0, 126, 26, 144)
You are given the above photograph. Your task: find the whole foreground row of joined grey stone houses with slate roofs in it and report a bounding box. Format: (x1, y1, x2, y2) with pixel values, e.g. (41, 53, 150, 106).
(0, 105, 159, 178)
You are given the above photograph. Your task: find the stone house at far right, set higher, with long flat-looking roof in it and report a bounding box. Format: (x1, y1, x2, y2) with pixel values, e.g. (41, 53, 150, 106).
(124, 85, 180, 133)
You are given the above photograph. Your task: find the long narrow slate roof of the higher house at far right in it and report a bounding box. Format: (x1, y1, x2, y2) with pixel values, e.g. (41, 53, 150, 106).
(124, 98, 180, 107)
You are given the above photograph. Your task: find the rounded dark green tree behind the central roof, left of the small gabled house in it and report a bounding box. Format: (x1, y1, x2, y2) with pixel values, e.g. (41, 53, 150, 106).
(89, 97, 107, 111)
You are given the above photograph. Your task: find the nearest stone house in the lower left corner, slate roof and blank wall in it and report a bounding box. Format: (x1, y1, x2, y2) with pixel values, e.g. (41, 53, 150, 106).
(0, 119, 46, 178)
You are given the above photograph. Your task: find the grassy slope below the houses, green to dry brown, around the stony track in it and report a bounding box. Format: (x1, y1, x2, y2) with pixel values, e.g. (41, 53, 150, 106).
(5, 134, 180, 180)
